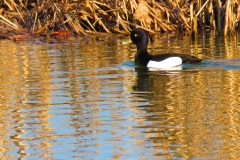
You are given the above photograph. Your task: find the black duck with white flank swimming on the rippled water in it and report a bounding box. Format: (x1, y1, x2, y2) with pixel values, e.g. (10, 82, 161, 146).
(124, 28, 202, 68)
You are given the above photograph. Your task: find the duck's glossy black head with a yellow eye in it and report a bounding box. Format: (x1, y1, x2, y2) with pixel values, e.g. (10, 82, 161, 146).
(130, 28, 149, 50)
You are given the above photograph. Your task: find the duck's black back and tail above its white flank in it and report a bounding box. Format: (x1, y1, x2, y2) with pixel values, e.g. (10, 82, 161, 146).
(151, 53, 202, 63)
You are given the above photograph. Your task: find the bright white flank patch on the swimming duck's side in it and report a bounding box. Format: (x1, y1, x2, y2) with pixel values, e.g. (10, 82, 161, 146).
(147, 57, 182, 69)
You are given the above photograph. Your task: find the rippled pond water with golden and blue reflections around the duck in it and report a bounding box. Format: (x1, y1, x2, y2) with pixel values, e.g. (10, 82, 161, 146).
(0, 33, 240, 160)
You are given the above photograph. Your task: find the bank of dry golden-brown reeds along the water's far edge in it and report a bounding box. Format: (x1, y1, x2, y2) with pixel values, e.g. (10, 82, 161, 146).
(0, 0, 240, 38)
